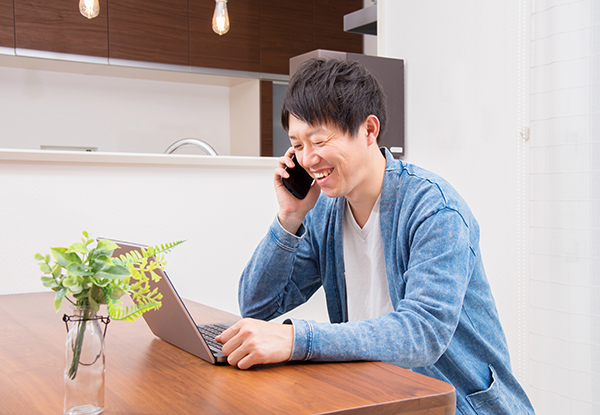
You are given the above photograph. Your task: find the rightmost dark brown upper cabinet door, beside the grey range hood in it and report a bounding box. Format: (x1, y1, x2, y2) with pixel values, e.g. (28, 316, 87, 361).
(314, 0, 363, 53)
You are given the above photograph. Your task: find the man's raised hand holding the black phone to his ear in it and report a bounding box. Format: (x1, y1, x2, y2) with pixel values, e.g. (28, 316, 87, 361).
(274, 147, 321, 234)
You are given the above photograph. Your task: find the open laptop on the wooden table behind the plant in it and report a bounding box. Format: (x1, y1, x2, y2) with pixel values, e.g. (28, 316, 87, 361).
(109, 238, 235, 364)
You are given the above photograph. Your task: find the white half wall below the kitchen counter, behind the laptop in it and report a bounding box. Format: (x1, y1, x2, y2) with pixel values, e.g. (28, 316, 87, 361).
(0, 155, 277, 313)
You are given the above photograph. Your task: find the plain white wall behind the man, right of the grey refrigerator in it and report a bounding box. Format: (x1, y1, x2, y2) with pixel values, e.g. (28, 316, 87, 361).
(377, 0, 526, 386)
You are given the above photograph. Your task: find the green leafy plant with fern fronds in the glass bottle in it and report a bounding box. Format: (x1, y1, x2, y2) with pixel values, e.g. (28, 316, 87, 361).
(35, 232, 183, 379)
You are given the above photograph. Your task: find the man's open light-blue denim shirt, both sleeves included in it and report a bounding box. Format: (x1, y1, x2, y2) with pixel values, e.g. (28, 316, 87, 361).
(239, 150, 534, 415)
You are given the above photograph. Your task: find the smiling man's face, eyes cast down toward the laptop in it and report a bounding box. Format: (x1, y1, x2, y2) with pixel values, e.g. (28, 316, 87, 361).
(288, 115, 369, 200)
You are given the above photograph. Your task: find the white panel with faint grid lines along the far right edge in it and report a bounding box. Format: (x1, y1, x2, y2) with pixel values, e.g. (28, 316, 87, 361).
(527, 0, 600, 415)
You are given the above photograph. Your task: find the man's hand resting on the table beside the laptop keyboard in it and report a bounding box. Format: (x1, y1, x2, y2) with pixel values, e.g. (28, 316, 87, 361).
(216, 318, 294, 369)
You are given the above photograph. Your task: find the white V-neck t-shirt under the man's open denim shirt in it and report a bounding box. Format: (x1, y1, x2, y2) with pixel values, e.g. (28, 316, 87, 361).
(343, 199, 394, 321)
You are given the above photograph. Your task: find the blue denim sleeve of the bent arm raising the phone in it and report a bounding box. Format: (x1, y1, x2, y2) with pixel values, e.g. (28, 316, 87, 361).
(238, 218, 321, 320)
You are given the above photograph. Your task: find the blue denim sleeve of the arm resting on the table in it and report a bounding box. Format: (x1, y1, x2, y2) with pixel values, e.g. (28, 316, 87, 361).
(291, 208, 474, 367)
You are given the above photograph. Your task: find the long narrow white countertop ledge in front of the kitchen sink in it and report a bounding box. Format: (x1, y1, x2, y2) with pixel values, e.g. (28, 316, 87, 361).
(0, 148, 277, 168)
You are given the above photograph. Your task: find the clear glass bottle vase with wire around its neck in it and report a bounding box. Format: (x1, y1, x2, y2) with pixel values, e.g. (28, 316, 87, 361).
(64, 307, 107, 415)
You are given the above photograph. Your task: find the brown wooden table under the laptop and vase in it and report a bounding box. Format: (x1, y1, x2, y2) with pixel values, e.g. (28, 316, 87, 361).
(0, 292, 456, 415)
